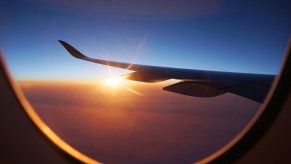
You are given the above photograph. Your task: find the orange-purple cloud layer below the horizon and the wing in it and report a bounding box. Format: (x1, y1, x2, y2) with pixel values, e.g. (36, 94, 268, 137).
(20, 82, 259, 163)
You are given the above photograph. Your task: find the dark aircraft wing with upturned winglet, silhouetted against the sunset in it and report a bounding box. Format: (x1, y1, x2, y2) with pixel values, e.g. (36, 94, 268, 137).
(59, 40, 275, 103)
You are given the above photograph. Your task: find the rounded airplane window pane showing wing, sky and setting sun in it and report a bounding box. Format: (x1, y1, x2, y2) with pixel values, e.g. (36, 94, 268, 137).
(0, 0, 291, 163)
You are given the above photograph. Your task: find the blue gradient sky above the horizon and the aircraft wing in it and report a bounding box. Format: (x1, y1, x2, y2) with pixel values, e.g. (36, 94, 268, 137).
(0, 0, 291, 80)
